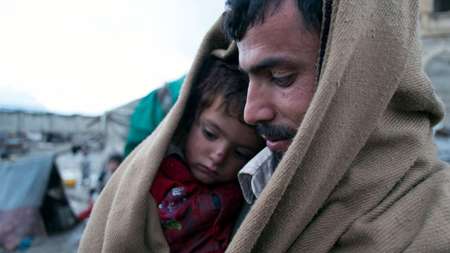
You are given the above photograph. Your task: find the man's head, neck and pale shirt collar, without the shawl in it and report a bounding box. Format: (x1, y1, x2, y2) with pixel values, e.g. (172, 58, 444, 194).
(225, 0, 322, 204)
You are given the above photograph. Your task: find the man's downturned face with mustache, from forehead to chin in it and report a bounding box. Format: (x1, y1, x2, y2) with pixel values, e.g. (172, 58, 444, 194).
(237, 0, 320, 153)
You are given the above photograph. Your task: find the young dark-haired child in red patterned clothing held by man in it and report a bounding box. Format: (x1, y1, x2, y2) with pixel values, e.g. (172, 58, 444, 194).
(150, 58, 264, 253)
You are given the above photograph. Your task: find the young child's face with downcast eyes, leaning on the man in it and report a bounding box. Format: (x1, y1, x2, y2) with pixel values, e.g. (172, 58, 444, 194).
(185, 99, 264, 184)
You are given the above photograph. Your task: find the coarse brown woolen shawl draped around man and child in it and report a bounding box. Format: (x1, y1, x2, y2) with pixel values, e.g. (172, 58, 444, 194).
(80, 0, 450, 253)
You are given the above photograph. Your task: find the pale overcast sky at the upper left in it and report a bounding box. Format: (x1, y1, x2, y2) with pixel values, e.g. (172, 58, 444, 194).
(0, 0, 225, 115)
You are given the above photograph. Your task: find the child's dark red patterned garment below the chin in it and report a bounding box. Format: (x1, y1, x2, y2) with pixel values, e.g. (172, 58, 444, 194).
(150, 155, 243, 253)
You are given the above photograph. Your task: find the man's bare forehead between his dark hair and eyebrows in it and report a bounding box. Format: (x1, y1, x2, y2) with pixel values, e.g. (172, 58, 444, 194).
(237, 1, 320, 73)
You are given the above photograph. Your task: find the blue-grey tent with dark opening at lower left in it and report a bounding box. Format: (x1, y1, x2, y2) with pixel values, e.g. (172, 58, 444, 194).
(0, 152, 76, 250)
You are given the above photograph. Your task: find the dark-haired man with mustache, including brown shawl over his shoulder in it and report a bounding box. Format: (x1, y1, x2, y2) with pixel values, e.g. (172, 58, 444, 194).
(224, 0, 450, 252)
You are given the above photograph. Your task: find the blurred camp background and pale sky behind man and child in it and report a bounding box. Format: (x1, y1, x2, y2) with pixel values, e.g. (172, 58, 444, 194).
(0, 0, 450, 252)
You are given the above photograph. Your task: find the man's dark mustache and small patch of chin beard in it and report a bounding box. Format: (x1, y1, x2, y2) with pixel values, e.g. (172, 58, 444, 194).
(256, 123, 297, 167)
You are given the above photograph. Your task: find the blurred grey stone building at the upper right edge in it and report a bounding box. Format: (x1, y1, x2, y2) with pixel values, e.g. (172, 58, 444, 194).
(420, 0, 450, 129)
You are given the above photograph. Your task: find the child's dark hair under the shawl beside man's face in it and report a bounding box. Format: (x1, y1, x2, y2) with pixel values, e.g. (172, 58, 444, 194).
(176, 56, 249, 142)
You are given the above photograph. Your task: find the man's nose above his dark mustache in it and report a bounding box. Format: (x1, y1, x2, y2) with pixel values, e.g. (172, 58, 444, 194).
(244, 81, 275, 125)
